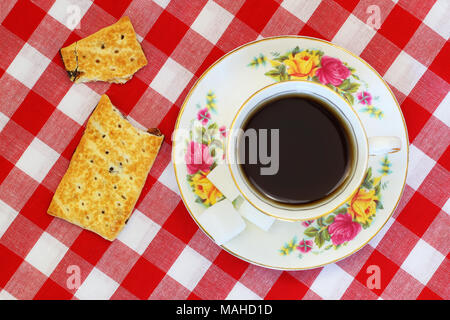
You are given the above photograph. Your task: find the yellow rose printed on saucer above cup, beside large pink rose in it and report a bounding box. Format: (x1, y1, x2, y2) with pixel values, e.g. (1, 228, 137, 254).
(284, 51, 320, 80)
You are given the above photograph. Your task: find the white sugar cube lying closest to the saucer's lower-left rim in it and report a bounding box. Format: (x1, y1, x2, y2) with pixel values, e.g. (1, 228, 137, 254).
(197, 199, 246, 245)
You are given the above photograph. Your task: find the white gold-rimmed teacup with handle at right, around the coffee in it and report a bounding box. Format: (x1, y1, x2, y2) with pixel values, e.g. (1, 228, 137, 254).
(226, 81, 401, 221)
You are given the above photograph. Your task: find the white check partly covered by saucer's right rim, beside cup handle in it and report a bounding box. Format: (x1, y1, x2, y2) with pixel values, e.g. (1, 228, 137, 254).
(406, 144, 436, 190)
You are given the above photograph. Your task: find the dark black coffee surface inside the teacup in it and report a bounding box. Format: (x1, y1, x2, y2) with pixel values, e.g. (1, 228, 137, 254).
(238, 96, 352, 205)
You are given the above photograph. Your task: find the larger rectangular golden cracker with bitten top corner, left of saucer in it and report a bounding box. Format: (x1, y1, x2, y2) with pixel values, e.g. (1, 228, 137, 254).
(47, 95, 164, 241)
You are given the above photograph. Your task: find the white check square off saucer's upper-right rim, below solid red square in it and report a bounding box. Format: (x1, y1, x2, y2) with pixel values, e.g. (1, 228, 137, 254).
(384, 51, 427, 95)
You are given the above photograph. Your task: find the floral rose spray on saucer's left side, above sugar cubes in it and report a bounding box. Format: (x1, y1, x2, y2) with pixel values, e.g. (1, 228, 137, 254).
(184, 91, 227, 207)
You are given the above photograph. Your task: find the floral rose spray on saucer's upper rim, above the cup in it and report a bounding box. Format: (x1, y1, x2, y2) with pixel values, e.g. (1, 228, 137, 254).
(248, 46, 384, 119)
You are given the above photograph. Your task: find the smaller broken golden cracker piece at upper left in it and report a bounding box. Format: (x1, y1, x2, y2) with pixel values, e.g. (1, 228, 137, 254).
(60, 17, 147, 83)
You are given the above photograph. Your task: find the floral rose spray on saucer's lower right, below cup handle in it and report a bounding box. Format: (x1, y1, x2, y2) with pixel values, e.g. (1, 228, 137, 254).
(279, 156, 392, 258)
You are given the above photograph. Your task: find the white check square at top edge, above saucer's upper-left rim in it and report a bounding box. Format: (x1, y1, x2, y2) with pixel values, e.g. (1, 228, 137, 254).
(191, 1, 233, 44)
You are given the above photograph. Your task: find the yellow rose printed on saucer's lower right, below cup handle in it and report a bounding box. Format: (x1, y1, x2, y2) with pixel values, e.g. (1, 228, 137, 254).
(348, 189, 378, 224)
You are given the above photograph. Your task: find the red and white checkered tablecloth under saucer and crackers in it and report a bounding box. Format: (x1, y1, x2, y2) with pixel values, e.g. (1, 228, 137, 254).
(0, 0, 450, 299)
